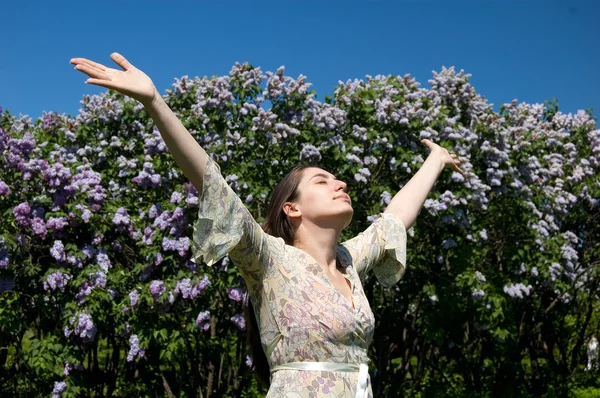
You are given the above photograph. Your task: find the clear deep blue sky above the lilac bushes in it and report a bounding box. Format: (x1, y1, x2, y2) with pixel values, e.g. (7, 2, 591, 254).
(0, 0, 600, 117)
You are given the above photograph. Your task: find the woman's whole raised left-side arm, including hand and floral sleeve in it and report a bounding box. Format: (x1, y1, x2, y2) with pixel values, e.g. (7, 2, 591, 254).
(71, 53, 284, 292)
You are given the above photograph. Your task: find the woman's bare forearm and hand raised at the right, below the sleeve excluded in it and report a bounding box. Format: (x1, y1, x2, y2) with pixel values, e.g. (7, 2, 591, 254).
(384, 140, 463, 229)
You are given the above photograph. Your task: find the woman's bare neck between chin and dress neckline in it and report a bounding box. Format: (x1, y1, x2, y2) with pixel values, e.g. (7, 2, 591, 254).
(294, 222, 341, 272)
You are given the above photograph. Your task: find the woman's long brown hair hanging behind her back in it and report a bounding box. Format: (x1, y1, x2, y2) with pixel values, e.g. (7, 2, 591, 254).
(245, 165, 318, 388)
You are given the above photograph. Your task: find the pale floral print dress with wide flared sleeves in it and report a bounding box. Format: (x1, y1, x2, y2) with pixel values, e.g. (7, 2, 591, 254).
(193, 158, 406, 398)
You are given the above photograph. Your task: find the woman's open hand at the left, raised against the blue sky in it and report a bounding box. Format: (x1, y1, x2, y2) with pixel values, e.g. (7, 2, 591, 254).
(70, 53, 160, 106)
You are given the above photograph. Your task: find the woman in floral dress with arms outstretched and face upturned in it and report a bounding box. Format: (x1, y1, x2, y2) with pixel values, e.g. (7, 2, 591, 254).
(71, 53, 462, 397)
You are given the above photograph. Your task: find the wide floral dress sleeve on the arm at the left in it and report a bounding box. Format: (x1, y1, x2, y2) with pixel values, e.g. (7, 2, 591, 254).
(192, 157, 283, 290)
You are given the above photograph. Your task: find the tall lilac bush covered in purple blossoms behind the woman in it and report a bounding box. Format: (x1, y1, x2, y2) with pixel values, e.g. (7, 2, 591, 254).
(0, 64, 600, 396)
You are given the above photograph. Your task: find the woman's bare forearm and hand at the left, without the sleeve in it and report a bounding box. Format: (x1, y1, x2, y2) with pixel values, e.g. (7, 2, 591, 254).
(71, 53, 207, 192)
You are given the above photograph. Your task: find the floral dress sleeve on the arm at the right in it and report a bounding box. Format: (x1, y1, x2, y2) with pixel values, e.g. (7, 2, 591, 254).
(342, 213, 406, 287)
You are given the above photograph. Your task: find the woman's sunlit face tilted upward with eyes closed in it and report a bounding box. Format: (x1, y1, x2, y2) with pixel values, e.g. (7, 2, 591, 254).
(284, 167, 354, 229)
